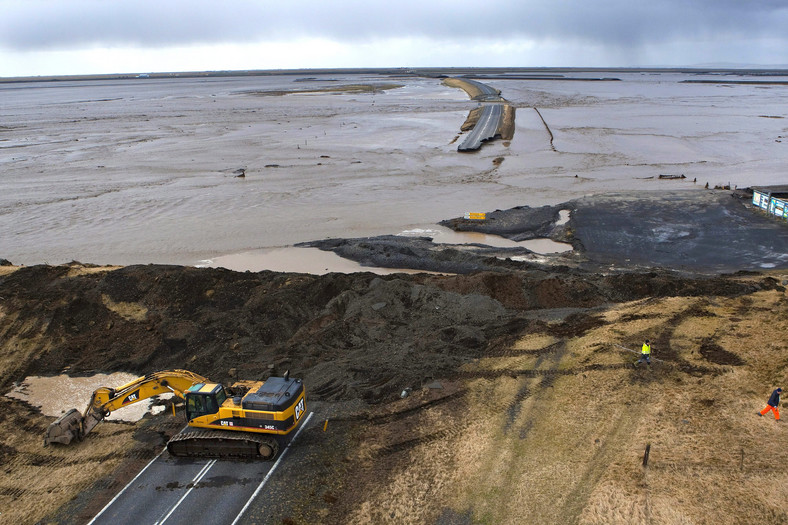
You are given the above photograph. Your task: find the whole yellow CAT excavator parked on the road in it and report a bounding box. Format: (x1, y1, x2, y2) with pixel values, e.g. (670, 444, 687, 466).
(44, 370, 306, 460)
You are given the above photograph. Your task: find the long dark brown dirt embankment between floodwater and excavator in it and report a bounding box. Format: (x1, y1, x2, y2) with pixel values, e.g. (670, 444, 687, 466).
(0, 266, 779, 399)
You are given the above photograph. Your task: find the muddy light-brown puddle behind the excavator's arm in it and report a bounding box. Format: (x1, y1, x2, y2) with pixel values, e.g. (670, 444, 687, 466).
(6, 372, 173, 421)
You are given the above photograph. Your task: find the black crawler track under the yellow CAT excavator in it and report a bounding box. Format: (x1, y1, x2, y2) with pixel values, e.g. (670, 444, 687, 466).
(167, 429, 279, 460)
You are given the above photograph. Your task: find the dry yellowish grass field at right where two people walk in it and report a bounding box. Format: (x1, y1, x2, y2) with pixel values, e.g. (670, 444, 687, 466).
(338, 276, 788, 524)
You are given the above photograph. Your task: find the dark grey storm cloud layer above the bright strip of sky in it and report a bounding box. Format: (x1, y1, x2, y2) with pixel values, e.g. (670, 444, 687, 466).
(0, 0, 788, 50)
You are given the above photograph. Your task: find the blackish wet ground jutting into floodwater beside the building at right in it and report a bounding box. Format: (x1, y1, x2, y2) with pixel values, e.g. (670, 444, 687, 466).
(440, 190, 788, 273)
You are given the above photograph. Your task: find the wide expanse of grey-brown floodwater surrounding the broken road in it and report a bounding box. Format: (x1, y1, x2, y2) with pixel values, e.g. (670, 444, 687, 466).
(0, 72, 788, 271)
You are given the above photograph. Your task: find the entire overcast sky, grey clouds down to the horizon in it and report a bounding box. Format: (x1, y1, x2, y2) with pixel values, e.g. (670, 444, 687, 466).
(0, 0, 788, 77)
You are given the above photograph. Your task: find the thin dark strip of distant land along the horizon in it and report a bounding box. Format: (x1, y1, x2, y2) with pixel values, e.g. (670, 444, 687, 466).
(0, 67, 788, 84)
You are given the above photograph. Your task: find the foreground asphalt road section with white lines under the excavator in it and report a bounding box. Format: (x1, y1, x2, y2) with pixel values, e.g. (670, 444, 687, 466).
(89, 413, 313, 525)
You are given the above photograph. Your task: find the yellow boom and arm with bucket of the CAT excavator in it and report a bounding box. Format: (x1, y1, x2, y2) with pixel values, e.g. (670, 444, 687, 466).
(44, 370, 209, 445)
